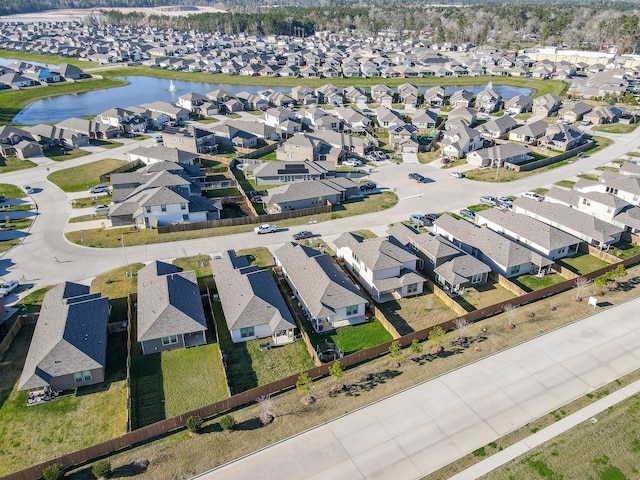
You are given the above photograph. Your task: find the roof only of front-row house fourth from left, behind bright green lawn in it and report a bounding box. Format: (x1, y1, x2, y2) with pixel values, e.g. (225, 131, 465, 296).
(275, 242, 367, 318)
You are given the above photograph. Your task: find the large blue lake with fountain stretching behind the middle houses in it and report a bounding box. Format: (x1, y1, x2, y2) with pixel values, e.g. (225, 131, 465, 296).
(13, 76, 532, 125)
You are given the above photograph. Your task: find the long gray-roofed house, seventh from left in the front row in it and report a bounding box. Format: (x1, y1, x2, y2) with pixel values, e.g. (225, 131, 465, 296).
(433, 214, 553, 278)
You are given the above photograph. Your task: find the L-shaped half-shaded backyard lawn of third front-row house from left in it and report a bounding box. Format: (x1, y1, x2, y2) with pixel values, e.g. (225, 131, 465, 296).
(212, 302, 314, 394)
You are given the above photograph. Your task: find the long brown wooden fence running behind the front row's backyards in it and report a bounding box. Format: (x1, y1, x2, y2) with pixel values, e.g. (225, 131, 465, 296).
(3, 255, 640, 480)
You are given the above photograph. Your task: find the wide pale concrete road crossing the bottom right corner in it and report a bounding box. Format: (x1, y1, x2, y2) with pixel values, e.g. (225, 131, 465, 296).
(196, 299, 640, 480)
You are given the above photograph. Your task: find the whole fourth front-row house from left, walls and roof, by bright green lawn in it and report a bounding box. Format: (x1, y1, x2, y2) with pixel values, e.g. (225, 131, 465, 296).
(275, 242, 368, 332)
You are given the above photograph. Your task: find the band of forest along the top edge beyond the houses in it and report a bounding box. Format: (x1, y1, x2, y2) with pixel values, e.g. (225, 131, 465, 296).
(0, 0, 640, 53)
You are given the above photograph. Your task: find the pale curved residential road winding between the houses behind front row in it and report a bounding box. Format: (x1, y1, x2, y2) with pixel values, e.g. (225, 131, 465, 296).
(0, 127, 640, 293)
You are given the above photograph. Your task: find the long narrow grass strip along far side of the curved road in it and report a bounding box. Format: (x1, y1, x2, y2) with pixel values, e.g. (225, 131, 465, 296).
(65, 192, 398, 248)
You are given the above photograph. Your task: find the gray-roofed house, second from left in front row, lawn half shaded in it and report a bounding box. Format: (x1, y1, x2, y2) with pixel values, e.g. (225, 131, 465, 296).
(136, 260, 207, 354)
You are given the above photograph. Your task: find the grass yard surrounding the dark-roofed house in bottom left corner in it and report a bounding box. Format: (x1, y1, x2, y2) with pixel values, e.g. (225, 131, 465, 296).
(0, 325, 127, 475)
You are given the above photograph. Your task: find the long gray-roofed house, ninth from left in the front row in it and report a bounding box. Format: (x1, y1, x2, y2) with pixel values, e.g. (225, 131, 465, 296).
(512, 197, 623, 248)
